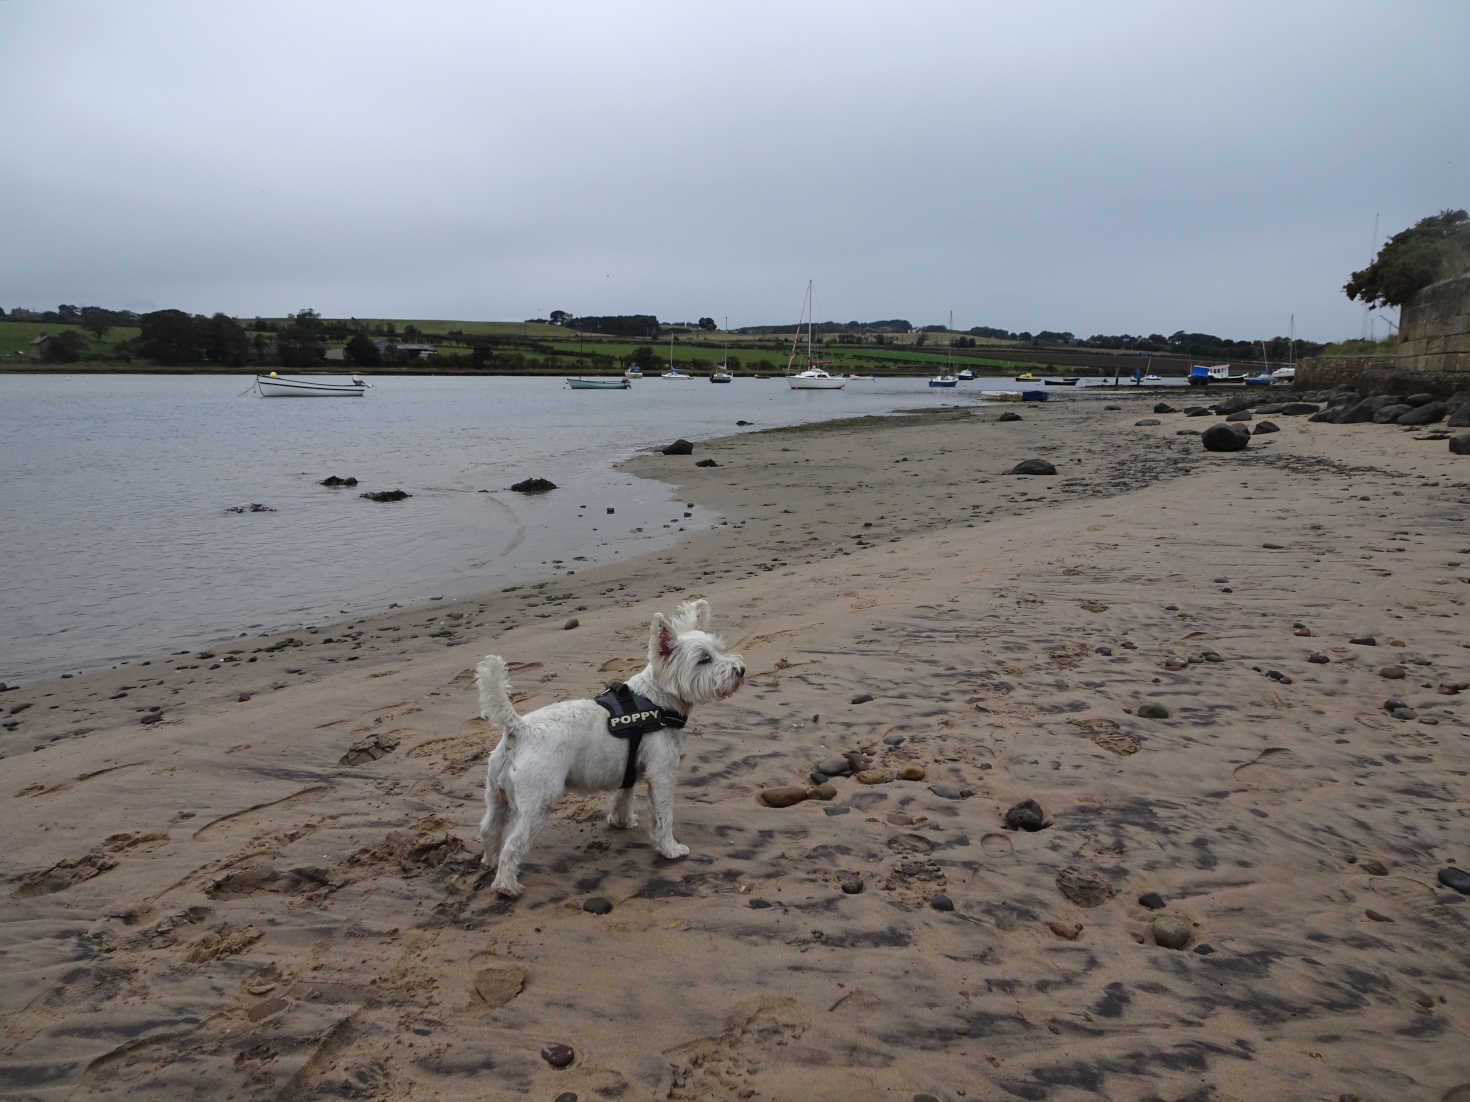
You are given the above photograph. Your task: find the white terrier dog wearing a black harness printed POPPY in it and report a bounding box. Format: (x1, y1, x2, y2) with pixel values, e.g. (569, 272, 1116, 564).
(475, 601, 745, 898)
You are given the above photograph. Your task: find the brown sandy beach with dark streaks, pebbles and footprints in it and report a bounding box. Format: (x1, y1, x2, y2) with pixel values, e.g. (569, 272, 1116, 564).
(0, 394, 1470, 1102)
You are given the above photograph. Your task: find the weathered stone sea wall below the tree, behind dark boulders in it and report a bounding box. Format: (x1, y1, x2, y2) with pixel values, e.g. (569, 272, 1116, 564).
(1297, 273, 1470, 395)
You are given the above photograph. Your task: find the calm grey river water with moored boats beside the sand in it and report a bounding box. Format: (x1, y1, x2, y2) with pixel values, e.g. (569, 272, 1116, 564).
(0, 375, 1101, 683)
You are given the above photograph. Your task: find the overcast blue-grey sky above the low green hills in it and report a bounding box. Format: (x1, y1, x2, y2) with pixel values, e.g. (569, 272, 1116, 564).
(0, 0, 1470, 339)
